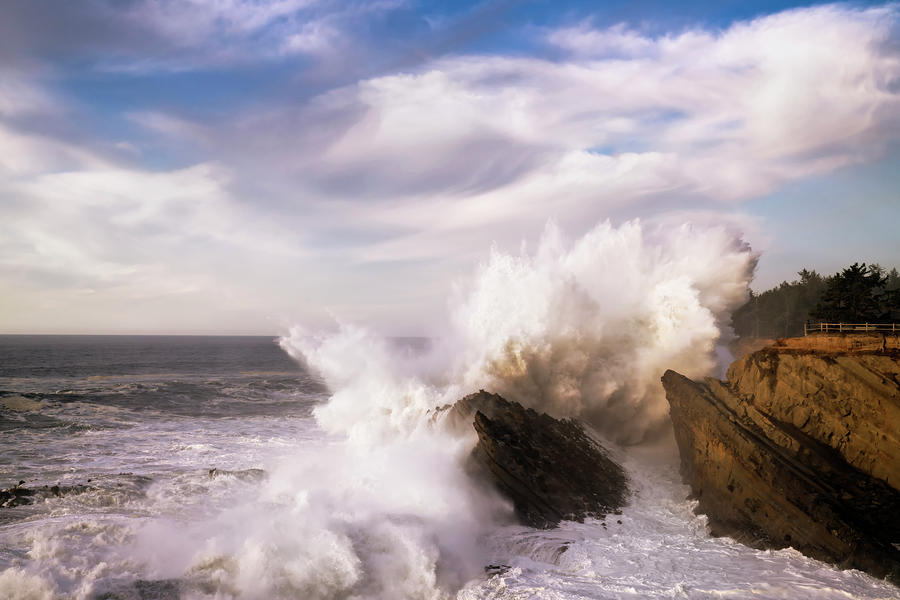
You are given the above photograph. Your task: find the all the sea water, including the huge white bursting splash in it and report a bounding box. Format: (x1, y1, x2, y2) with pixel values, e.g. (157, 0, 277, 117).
(0, 221, 900, 600)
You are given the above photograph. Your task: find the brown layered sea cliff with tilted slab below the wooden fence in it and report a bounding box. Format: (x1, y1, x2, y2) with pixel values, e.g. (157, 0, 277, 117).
(662, 344, 900, 581)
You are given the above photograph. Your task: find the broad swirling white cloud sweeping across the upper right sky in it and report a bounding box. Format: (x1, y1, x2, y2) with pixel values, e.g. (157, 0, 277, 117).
(186, 1, 900, 254)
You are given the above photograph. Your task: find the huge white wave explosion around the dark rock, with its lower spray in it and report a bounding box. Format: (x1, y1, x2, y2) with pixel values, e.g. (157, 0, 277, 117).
(236, 221, 755, 598)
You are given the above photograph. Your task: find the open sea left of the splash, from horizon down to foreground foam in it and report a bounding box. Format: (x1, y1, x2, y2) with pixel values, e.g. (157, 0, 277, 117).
(0, 336, 342, 598)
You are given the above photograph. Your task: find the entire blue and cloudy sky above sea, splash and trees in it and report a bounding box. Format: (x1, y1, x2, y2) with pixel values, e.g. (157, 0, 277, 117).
(0, 0, 900, 335)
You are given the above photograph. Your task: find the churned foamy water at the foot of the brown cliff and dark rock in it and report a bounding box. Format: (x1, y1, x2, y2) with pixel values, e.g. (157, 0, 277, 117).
(459, 440, 900, 600)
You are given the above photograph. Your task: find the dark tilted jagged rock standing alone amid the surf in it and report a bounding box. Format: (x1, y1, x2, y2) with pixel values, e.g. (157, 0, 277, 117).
(447, 391, 628, 528)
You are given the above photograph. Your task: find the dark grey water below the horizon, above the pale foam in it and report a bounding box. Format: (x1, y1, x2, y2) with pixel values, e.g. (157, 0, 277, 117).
(0, 336, 325, 478)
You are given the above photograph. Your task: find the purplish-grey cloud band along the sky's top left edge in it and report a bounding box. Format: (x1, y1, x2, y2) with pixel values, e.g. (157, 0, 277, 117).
(0, 0, 403, 75)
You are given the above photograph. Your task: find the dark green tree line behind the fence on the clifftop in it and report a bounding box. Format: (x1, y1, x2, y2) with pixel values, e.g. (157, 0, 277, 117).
(731, 263, 900, 337)
